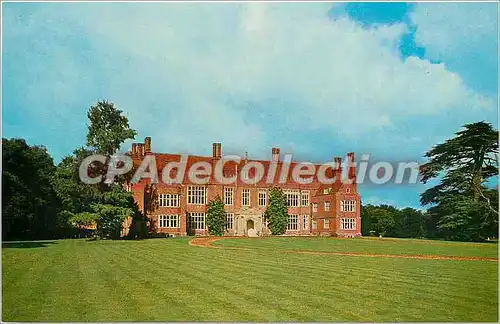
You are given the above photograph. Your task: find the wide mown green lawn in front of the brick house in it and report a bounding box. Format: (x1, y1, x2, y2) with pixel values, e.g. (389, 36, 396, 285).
(2, 237, 498, 322)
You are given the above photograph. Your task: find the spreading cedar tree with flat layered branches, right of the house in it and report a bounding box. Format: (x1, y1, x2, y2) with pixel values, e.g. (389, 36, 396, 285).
(420, 122, 498, 240)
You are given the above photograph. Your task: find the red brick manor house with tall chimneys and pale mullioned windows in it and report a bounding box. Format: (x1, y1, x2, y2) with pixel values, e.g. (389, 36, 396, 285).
(124, 137, 361, 237)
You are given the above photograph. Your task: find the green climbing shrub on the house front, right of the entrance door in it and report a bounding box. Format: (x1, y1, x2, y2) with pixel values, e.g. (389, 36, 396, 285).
(264, 187, 288, 235)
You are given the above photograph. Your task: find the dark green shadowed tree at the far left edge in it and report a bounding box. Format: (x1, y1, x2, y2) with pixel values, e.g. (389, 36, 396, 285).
(2, 138, 66, 240)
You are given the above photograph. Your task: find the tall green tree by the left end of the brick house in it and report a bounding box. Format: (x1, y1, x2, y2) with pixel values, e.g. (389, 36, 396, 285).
(54, 101, 140, 238)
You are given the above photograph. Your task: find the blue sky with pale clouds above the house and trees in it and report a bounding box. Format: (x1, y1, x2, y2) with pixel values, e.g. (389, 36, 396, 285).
(2, 2, 498, 208)
